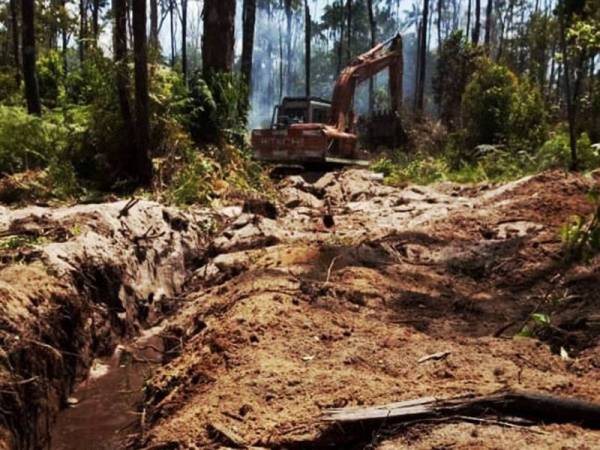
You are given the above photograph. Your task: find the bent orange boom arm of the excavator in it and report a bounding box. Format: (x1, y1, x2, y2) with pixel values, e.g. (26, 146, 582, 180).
(331, 34, 403, 133)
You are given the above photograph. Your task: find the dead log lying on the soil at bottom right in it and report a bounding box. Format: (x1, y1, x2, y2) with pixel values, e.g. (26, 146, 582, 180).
(321, 391, 600, 429)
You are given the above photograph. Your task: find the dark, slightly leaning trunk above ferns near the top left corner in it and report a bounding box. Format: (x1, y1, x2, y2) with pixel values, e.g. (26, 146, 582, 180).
(21, 0, 42, 116)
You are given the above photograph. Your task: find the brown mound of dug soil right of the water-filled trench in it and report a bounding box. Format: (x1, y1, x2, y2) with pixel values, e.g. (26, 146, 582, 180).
(132, 171, 600, 450)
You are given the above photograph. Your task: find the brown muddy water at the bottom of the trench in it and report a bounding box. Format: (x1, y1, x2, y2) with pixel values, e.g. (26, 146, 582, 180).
(49, 330, 160, 450)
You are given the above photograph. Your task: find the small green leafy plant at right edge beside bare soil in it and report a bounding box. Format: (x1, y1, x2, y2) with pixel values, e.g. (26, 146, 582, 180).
(560, 190, 600, 262)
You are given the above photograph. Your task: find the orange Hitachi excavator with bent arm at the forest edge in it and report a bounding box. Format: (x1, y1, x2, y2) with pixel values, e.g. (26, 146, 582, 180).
(251, 34, 403, 166)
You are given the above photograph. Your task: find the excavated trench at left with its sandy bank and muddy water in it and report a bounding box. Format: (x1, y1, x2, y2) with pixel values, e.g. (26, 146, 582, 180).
(0, 201, 214, 450)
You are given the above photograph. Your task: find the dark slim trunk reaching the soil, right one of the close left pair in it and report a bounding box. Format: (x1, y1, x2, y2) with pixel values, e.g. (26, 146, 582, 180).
(132, 0, 152, 185)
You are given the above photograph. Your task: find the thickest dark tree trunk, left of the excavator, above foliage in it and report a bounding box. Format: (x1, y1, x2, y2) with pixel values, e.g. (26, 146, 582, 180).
(202, 0, 236, 75)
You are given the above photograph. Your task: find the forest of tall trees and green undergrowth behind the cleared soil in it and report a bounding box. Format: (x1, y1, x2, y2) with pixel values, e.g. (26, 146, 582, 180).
(0, 0, 600, 203)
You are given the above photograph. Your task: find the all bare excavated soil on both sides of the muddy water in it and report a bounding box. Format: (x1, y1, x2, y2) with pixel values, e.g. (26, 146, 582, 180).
(0, 170, 600, 450)
